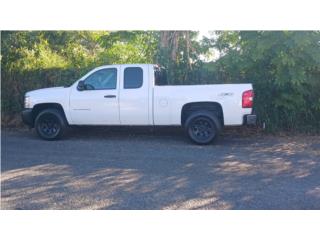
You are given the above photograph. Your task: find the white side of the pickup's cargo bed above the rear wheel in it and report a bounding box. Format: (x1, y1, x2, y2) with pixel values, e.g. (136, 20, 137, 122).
(153, 84, 252, 126)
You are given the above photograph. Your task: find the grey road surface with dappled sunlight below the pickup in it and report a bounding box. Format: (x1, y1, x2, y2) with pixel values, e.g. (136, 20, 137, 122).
(1, 128, 320, 209)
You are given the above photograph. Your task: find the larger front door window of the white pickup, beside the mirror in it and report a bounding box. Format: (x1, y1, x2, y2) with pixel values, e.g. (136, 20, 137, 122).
(84, 68, 117, 90)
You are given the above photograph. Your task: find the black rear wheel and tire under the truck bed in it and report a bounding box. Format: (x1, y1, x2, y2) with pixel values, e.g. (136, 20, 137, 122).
(185, 111, 222, 145)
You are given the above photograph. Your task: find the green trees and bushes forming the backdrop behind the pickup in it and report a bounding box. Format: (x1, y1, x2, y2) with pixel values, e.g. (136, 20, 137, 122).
(1, 31, 320, 133)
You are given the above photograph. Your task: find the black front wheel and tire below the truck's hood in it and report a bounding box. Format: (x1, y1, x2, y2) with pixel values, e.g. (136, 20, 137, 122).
(35, 108, 67, 141)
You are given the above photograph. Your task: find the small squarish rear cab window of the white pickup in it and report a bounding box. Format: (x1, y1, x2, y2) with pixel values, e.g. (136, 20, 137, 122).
(123, 67, 143, 89)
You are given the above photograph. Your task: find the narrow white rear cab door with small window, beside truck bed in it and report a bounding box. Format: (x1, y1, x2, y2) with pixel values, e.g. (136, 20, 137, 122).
(120, 65, 149, 125)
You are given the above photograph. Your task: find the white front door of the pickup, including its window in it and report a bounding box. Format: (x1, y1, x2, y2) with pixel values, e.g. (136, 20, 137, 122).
(70, 66, 120, 125)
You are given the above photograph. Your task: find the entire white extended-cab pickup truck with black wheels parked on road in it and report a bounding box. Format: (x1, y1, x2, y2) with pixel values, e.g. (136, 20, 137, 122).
(22, 64, 256, 144)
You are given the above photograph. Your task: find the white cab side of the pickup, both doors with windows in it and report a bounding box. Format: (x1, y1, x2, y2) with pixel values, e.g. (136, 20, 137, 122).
(69, 64, 152, 125)
